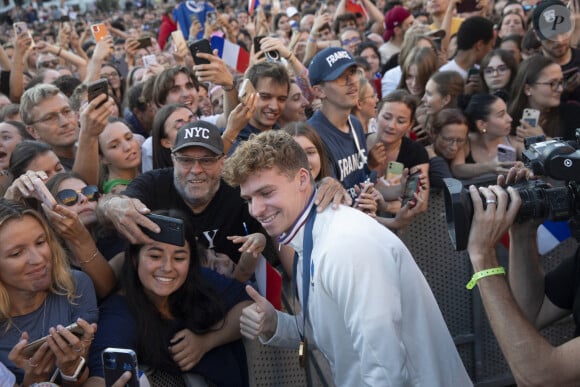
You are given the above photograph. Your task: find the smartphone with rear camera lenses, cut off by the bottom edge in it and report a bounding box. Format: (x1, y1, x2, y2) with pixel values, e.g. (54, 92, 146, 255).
(101, 348, 139, 387)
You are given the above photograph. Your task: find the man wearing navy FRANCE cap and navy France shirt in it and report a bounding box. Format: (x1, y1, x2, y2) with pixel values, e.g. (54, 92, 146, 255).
(308, 47, 370, 199)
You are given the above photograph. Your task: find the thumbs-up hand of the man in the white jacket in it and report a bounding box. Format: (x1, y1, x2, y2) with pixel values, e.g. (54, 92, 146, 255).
(240, 285, 278, 341)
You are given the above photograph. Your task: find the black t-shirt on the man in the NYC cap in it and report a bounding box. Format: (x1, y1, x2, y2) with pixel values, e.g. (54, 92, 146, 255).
(124, 168, 277, 264)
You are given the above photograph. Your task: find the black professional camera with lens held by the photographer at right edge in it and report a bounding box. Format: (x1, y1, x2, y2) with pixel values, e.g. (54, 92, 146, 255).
(443, 129, 580, 251)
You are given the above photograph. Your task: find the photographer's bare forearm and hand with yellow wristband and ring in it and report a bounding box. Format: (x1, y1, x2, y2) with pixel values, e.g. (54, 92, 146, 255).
(468, 186, 580, 386)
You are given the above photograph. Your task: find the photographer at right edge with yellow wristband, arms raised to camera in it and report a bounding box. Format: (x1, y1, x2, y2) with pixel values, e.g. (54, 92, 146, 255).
(468, 168, 580, 386)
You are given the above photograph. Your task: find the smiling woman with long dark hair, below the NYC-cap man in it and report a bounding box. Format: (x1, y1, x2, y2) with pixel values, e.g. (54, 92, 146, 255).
(90, 210, 249, 386)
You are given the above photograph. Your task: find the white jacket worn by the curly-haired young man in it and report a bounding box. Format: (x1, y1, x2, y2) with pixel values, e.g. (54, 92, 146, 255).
(265, 206, 472, 387)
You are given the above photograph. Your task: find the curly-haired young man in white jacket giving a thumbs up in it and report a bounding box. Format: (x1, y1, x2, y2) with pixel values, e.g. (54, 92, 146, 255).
(224, 131, 472, 386)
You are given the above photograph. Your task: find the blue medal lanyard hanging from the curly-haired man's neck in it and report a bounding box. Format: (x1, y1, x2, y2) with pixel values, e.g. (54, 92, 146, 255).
(292, 206, 316, 340)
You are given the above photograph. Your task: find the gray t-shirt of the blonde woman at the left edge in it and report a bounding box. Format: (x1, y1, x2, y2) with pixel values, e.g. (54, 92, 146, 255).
(0, 270, 99, 383)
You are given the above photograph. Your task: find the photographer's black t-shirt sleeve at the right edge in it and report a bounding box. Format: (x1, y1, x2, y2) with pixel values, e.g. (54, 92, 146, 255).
(544, 248, 580, 336)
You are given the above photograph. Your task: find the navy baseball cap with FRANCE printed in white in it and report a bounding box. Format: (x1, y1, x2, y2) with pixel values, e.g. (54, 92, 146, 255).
(308, 47, 356, 86)
